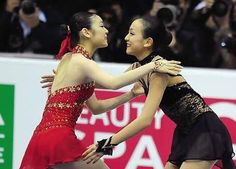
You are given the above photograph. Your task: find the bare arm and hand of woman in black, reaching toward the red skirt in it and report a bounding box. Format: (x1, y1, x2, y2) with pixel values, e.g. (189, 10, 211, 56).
(83, 73, 168, 162)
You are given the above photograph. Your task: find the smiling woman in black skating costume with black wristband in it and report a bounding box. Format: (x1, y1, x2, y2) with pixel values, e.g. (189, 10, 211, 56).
(84, 17, 235, 169)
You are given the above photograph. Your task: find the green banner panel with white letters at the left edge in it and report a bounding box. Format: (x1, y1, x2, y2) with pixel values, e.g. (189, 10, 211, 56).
(0, 84, 14, 169)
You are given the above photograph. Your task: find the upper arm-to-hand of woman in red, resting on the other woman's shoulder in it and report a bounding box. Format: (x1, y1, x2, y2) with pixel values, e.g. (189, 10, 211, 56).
(80, 59, 180, 89)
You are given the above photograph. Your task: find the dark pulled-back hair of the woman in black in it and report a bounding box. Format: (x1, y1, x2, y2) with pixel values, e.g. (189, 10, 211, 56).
(140, 16, 172, 50)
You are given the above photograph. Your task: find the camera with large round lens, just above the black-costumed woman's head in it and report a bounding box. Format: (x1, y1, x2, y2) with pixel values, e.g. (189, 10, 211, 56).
(157, 4, 181, 27)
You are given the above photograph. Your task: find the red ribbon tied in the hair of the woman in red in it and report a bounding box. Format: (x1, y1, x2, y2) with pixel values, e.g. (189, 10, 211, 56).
(56, 30, 72, 59)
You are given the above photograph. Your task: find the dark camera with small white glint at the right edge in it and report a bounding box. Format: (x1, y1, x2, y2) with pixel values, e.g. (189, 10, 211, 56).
(220, 34, 236, 56)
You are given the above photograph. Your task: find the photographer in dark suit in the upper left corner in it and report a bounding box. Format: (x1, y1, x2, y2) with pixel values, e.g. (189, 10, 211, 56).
(0, 0, 61, 54)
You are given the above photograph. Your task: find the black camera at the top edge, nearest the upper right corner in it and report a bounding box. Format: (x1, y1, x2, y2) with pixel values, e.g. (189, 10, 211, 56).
(211, 0, 232, 17)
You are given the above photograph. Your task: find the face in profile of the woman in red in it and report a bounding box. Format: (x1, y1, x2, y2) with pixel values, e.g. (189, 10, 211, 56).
(91, 15, 108, 48)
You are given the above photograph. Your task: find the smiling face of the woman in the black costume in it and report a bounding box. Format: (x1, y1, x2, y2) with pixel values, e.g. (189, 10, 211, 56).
(125, 19, 150, 59)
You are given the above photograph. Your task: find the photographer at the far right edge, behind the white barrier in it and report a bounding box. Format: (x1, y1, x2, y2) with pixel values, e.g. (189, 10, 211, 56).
(212, 1, 236, 69)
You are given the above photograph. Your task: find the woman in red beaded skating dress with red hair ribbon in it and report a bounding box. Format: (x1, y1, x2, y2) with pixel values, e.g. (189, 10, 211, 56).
(20, 12, 181, 169)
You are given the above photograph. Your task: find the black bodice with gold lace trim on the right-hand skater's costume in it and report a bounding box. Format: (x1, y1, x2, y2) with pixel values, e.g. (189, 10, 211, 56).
(132, 55, 213, 130)
